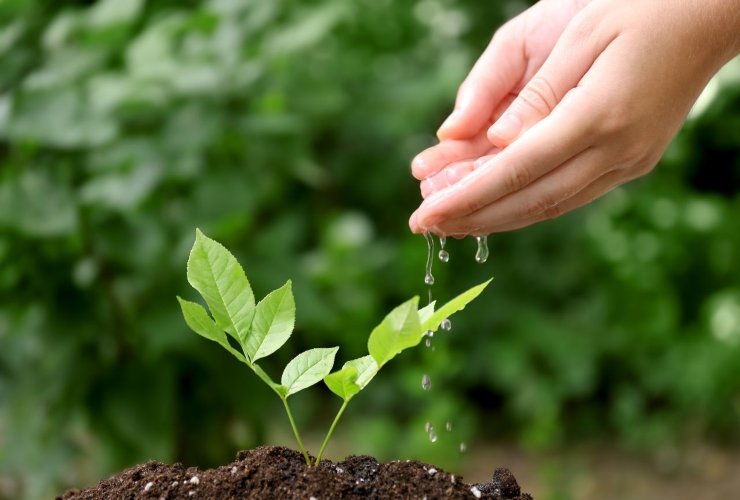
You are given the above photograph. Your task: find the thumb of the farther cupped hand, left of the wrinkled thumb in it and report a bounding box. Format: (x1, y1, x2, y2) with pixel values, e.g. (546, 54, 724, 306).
(437, 26, 527, 141)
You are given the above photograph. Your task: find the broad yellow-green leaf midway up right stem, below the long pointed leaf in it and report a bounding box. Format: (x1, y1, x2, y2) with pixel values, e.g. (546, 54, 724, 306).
(367, 297, 422, 367)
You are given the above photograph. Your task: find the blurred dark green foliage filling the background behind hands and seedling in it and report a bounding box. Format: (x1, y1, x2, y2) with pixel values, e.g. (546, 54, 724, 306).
(0, 0, 740, 498)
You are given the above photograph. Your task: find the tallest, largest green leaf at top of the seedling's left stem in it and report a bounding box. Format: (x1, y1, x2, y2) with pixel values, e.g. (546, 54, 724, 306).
(188, 229, 254, 345)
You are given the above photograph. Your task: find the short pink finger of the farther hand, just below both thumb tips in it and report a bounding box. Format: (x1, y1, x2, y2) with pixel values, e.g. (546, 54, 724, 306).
(411, 131, 492, 180)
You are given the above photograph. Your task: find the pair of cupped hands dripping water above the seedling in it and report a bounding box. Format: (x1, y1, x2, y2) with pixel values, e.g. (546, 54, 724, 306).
(409, 0, 740, 235)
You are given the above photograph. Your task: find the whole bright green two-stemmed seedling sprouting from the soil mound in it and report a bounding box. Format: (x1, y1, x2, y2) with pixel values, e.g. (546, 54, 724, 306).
(177, 229, 491, 466)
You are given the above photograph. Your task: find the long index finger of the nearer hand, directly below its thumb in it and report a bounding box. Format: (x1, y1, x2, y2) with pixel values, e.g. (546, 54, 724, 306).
(410, 88, 592, 232)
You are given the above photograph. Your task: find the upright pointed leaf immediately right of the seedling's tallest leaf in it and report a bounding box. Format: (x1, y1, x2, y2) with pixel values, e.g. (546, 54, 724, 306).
(249, 280, 295, 362)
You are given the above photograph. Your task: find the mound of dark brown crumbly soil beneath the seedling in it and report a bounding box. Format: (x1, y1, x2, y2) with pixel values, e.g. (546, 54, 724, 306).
(57, 446, 532, 500)
